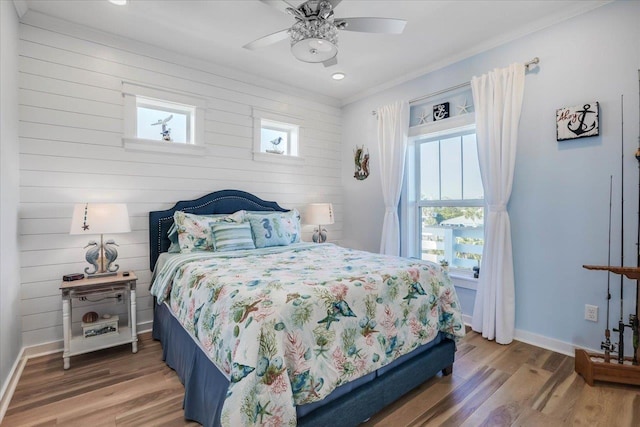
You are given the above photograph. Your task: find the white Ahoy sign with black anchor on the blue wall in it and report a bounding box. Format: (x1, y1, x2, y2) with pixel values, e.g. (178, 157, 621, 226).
(556, 101, 600, 141)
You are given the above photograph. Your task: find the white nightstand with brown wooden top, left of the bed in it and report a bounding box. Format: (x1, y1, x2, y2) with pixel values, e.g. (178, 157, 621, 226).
(60, 272, 138, 369)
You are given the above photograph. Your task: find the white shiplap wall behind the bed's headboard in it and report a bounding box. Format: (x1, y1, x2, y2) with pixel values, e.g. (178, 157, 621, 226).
(18, 12, 342, 346)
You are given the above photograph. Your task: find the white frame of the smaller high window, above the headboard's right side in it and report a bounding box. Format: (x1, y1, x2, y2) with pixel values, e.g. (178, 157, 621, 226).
(252, 107, 304, 164)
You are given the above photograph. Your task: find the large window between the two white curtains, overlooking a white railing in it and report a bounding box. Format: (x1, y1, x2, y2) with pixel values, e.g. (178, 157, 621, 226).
(404, 123, 484, 271)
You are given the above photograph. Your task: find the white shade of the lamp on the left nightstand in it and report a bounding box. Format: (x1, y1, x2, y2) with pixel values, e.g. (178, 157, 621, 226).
(69, 203, 131, 234)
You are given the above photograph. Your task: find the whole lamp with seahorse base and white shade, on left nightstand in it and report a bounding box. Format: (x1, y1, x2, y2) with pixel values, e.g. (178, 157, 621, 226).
(69, 203, 131, 278)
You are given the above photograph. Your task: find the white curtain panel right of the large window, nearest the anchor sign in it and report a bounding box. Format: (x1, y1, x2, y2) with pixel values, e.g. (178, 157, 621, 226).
(471, 64, 525, 344)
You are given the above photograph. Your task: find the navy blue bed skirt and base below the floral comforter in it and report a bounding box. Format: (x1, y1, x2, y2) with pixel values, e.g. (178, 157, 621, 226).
(153, 304, 455, 427)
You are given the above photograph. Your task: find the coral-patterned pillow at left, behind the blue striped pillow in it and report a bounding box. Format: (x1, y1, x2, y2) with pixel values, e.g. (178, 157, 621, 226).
(173, 211, 244, 253)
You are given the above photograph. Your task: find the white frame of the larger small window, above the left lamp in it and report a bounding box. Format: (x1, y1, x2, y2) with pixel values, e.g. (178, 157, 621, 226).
(122, 82, 206, 155)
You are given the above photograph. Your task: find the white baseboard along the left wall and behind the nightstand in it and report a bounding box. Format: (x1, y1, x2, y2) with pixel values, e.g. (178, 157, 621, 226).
(0, 320, 153, 424)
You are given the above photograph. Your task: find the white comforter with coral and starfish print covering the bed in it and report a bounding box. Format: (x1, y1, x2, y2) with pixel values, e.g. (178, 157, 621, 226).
(151, 243, 464, 426)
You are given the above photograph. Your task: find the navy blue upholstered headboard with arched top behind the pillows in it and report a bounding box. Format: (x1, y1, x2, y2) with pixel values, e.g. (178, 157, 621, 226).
(149, 190, 288, 271)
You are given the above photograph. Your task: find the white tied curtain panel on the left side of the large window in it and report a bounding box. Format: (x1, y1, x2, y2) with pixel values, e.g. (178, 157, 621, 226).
(378, 101, 409, 256)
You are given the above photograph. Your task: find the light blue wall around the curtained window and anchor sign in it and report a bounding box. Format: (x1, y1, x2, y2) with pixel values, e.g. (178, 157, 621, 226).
(343, 1, 640, 352)
